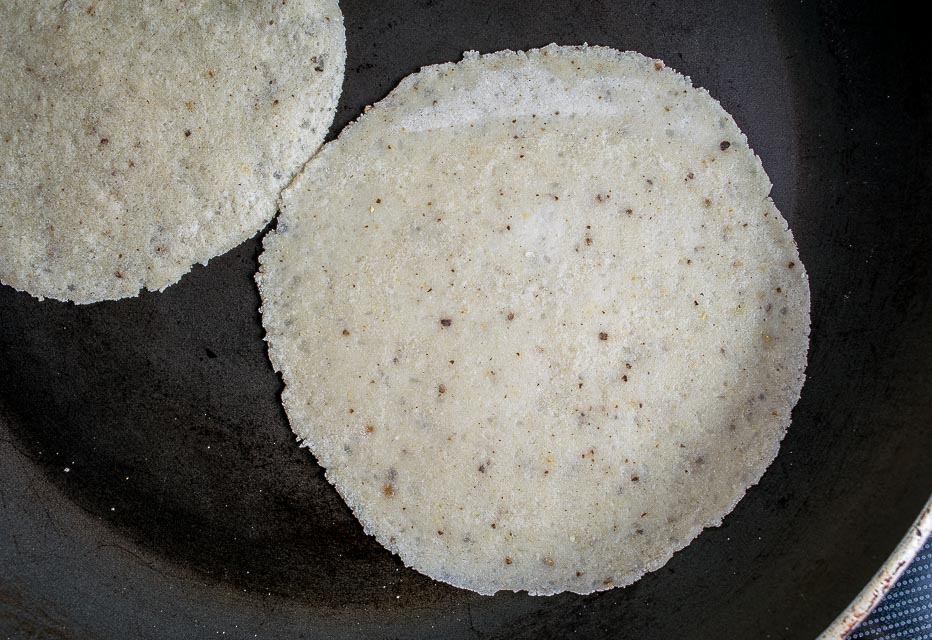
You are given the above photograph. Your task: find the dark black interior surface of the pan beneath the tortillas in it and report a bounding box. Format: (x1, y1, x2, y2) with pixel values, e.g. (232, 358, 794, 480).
(0, 0, 932, 640)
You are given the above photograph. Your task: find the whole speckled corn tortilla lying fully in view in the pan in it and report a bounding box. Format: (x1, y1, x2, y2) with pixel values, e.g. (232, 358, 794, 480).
(257, 45, 809, 594)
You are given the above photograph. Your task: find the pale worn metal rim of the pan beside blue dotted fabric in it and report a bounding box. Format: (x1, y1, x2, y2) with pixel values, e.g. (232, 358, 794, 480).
(816, 495, 932, 640)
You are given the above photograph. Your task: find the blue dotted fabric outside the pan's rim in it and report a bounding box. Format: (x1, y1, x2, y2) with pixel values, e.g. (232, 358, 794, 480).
(848, 538, 932, 640)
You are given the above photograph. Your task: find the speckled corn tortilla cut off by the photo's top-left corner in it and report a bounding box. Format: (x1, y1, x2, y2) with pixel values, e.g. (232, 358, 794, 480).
(0, 0, 346, 303)
